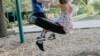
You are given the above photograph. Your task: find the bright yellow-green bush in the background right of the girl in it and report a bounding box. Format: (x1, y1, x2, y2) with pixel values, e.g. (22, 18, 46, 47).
(75, 0, 94, 14)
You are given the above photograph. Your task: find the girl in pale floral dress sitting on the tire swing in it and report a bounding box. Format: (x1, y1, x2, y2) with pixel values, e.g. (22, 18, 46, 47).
(36, 0, 73, 50)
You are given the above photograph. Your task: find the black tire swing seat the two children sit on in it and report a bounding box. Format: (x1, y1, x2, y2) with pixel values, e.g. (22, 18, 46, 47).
(30, 16, 66, 34)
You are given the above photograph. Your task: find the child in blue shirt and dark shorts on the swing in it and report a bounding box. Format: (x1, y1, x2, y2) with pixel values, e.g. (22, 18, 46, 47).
(30, 0, 55, 51)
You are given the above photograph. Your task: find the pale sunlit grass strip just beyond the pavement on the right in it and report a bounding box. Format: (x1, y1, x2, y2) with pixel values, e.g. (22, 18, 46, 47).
(74, 13, 100, 21)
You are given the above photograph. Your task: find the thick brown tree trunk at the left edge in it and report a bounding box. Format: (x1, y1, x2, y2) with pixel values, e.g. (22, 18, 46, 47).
(0, 0, 7, 37)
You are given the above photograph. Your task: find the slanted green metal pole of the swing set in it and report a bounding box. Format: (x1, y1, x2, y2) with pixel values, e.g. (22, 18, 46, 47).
(15, 0, 24, 43)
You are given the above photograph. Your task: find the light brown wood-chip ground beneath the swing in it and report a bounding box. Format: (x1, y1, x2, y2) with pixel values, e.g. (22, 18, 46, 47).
(0, 28, 100, 56)
